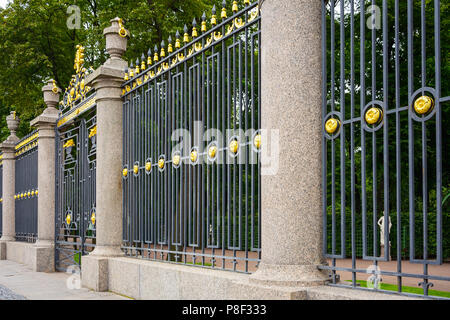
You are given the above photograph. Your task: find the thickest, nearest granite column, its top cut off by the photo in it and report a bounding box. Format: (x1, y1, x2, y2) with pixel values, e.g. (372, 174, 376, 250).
(251, 0, 327, 287)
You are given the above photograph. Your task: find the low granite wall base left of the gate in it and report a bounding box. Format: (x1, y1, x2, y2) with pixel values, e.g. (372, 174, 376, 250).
(0, 241, 55, 272)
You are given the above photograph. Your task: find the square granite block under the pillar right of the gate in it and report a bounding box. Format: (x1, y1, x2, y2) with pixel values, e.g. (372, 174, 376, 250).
(81, 255, 108, 292)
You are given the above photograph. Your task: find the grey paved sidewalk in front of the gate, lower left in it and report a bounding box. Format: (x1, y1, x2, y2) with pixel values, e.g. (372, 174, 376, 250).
(0, 260, 128, 300)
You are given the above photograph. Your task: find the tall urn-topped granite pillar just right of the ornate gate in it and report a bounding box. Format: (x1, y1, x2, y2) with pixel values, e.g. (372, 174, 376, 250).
(81, 18, 128, 291)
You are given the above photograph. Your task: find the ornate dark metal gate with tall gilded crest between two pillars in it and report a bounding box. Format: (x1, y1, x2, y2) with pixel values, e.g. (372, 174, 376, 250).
(55, 46, 97, 271)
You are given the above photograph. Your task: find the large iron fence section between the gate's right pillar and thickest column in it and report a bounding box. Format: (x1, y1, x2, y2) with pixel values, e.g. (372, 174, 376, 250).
(123, 1, 261, 273)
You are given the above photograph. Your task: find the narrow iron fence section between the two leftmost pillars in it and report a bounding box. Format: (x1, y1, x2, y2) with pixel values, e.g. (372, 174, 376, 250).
(14, 131, 38, 242)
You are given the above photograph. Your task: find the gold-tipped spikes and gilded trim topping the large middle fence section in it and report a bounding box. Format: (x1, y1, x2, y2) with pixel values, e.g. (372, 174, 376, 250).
(119, 0, 259, 95)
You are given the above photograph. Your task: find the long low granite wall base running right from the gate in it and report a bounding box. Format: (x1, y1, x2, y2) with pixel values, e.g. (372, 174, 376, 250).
(81, 256, 422, 300)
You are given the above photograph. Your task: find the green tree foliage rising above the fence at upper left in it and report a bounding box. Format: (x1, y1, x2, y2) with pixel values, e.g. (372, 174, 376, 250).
(0, 0, 231, 140)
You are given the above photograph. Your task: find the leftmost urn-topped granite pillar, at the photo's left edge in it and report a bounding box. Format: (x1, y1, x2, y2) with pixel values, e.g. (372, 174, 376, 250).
(0, 111, 20, 260)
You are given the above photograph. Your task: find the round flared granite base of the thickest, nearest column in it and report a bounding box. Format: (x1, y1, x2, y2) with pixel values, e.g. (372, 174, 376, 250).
(250, 263, 329, 287)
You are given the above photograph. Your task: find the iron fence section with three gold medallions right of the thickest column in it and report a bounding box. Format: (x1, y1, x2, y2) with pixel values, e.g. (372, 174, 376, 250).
(322, 0, 450, 296)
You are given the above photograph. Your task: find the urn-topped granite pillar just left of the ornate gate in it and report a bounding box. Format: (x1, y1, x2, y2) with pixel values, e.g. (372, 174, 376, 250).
(30, 80, 61, 272)
